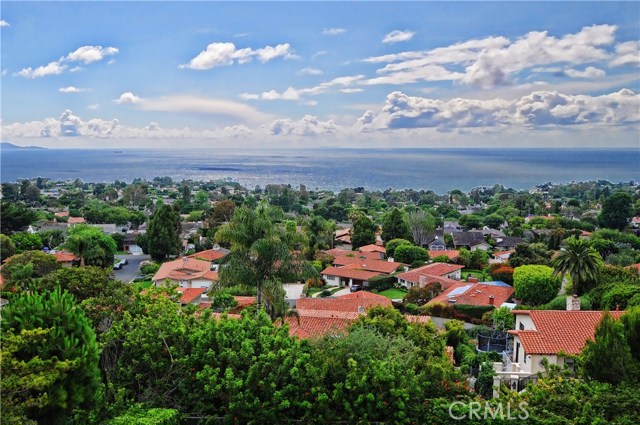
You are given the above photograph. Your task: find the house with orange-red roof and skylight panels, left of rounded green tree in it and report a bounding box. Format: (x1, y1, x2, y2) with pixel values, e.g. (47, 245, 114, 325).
(427, 281, 514, 307)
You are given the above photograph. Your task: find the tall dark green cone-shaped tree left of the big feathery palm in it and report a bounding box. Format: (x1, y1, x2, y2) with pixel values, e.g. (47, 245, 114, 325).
(147, 205, 181, 261)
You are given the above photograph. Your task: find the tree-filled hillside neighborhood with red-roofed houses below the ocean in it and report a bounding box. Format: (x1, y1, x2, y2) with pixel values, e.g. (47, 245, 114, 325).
(0, 177, 640, 423)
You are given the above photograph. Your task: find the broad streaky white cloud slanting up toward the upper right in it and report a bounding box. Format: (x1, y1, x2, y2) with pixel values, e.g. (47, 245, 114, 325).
(364, 25, 620, 88)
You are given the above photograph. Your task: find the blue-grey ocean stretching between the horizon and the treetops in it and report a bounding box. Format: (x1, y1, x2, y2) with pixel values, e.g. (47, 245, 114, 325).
(0, 149, 640, 193)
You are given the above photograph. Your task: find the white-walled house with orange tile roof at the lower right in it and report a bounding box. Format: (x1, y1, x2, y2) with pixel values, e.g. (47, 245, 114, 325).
(509, 310, 624, 374)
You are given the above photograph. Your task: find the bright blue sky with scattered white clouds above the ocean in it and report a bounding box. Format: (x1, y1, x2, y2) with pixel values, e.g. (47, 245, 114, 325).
(0, 0, 640, 149)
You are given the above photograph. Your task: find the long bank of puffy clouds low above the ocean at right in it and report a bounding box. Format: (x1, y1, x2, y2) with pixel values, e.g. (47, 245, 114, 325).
(358, 89, 640, 131)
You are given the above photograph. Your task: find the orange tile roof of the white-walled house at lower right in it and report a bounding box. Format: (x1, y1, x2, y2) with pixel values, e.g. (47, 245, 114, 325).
(509, 310, 624, 355)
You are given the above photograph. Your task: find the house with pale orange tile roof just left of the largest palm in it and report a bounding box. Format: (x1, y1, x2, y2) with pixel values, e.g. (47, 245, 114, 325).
(151, 257, 218, 288)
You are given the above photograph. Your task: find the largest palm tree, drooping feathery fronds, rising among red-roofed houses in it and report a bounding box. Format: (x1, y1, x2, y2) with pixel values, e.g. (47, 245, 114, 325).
(215, 204, 315, 310)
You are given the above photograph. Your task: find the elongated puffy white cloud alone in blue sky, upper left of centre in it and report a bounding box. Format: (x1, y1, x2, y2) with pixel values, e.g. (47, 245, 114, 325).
(179, 43, 296, 70)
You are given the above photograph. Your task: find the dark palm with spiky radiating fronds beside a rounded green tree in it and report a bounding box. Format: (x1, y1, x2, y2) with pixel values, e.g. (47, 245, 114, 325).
(551, 237, 602, 297)
